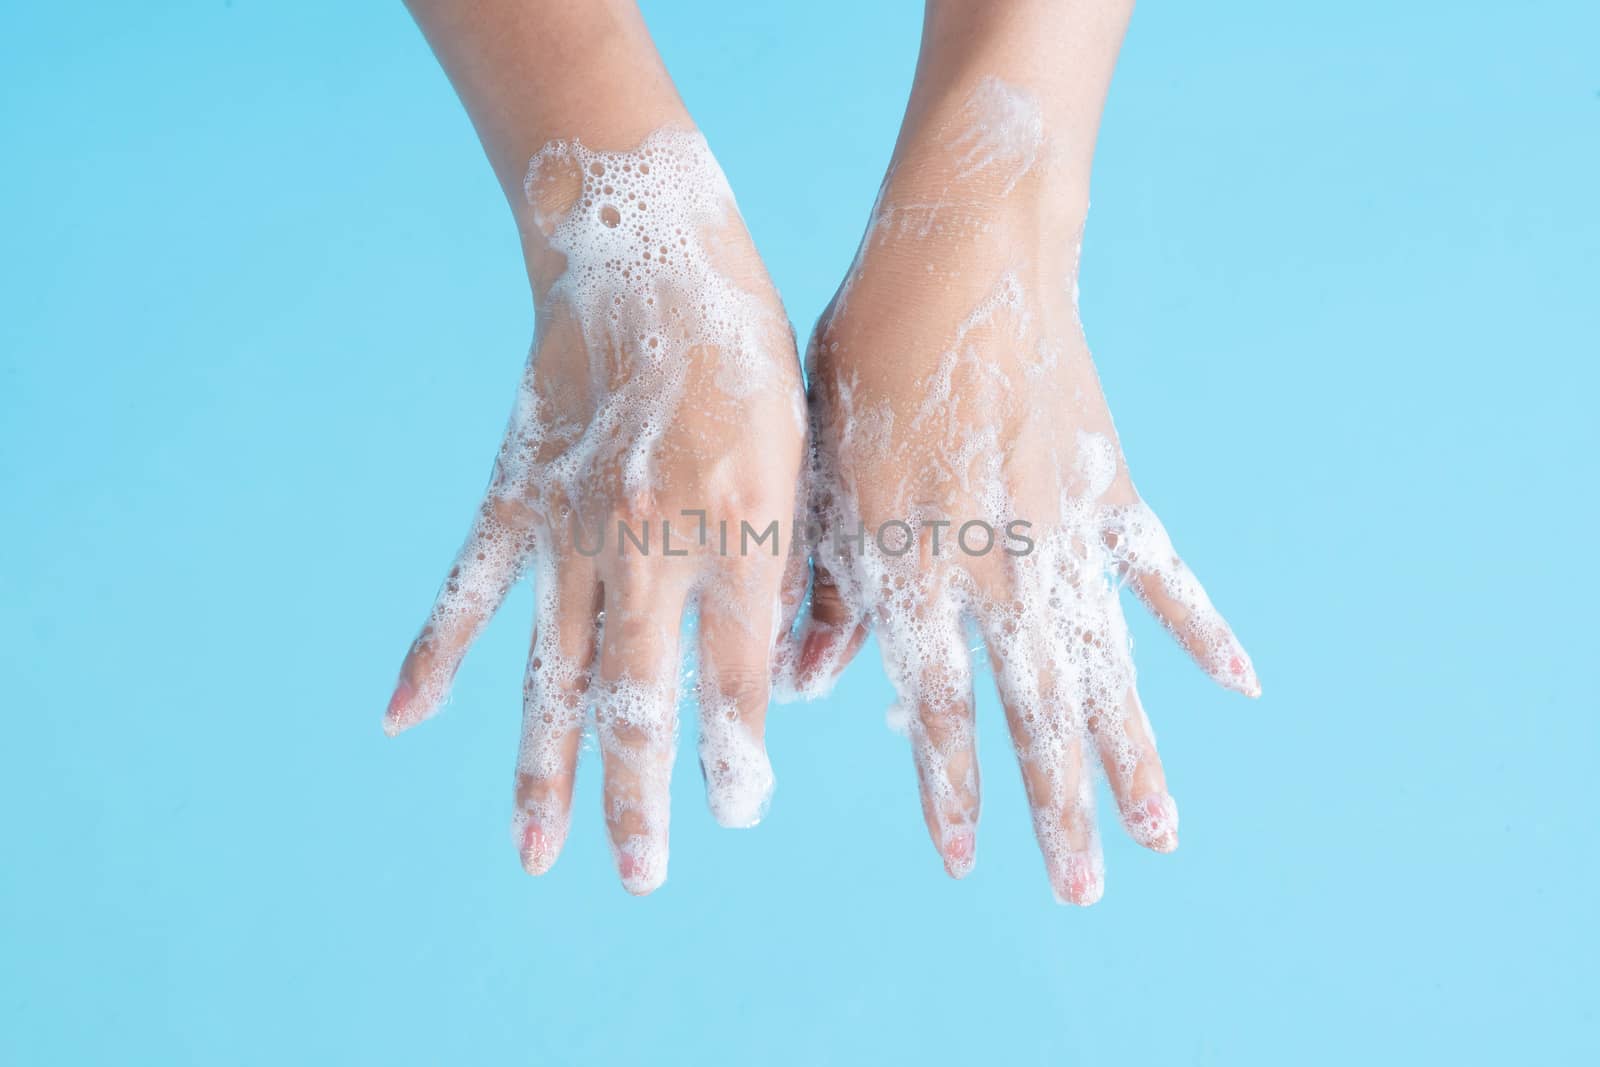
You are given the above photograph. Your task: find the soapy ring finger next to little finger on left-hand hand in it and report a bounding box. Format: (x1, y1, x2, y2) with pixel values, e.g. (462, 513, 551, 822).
(512, 555, 600, 875)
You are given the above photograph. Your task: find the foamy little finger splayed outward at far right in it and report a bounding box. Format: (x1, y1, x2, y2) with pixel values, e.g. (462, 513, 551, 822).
(1106, 502, 1261, 697)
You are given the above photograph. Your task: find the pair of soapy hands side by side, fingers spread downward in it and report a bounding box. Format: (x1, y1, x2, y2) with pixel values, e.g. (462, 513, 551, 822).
(384, 131, 1259, 904)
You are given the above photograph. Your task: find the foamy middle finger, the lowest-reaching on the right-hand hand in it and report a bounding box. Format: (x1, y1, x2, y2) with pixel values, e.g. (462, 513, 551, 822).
(984, 609, 1106, 907)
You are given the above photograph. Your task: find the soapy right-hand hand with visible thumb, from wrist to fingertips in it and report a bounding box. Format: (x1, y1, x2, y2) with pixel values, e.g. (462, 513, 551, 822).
(798, 62, 1259, 904)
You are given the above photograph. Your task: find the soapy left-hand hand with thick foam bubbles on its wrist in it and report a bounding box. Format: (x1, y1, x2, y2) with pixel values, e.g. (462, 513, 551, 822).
(384, 128, 803, 894)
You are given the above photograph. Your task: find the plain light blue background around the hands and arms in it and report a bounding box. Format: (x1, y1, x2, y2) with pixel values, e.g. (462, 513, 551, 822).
(0, 0, 1600, 1064)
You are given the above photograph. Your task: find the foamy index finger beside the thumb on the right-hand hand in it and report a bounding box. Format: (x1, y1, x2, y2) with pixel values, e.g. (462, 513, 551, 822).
(880, 592, 979, 878)
